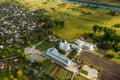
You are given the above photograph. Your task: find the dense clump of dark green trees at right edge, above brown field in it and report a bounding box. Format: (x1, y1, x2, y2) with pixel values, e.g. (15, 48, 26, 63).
(92, 25, 120, 51)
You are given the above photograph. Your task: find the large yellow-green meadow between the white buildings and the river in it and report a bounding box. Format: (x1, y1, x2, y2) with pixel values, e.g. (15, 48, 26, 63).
(52, 4, 120, 41)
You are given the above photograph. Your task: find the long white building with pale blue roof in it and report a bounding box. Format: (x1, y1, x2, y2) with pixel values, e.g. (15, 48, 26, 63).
(45, 48, 72, 66)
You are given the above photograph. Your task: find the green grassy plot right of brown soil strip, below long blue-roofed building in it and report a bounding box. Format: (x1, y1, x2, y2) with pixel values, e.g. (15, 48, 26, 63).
(56, 68, 73, 80)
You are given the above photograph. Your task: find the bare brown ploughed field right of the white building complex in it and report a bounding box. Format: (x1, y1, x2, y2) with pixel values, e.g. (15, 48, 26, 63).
(79, 51, 120, 80)
